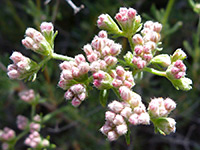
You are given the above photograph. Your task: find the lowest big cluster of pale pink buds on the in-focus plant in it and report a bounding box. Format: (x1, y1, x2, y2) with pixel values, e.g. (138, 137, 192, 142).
(100, 95, 150, 141)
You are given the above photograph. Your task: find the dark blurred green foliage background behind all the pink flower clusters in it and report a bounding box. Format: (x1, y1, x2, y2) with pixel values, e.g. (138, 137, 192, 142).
(0, 0, 200, 150)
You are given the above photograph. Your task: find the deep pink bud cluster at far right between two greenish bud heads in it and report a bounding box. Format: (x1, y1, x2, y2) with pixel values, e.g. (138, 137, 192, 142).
(166, 60, 186, 79)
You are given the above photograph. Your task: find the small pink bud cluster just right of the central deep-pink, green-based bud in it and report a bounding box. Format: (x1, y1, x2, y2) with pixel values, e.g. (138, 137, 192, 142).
(110, 66, 135, 88)
